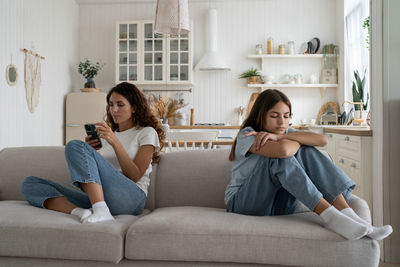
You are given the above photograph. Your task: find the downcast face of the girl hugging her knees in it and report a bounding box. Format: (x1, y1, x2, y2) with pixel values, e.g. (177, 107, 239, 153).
(265, 101, 290, 134)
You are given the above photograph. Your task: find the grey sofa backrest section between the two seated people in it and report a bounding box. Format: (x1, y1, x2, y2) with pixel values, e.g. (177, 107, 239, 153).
(152, 149, 232, 208)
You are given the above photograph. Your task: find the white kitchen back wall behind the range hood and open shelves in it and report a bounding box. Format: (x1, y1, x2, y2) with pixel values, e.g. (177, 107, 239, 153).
(79, 0, 342, 124)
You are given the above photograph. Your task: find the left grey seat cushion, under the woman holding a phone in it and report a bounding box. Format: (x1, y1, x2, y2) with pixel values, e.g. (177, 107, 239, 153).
(0, 200, 137, 263)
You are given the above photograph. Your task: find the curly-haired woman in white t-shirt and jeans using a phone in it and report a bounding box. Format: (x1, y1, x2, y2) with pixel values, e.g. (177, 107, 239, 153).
(21, 82, 165, 223)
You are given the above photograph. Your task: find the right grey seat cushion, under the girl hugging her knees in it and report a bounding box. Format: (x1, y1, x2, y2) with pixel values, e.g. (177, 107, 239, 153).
(125, 207, 379, 266)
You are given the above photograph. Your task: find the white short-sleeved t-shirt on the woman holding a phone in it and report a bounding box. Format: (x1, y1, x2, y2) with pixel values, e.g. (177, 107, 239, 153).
(98, 127, 160, 196)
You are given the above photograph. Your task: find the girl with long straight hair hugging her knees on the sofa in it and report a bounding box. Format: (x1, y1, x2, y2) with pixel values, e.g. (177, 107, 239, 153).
(225, 89, 392, 240)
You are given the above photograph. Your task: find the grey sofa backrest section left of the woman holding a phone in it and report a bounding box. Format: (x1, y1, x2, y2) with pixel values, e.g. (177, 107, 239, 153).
(0, 146, 72, 200)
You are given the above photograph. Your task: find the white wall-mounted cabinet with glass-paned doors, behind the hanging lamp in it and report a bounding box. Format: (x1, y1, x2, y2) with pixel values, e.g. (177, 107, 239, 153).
(115, 21, 193, 85)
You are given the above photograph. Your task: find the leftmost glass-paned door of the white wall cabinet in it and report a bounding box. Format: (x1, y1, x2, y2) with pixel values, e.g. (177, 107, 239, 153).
(117, 23, 139, 82)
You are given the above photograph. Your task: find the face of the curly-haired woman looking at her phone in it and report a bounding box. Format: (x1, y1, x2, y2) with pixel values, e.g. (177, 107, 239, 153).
(108, 93, 134, 124)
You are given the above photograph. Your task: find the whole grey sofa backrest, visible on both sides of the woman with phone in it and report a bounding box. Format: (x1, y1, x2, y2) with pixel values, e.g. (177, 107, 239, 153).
(0, 146, 232, 210)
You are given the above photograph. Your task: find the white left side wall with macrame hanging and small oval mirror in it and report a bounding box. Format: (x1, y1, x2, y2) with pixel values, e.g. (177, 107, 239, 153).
(0, 0, 79, 149)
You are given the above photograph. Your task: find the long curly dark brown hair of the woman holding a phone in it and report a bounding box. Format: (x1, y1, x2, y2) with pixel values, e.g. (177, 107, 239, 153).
(105, 82, 165, 163)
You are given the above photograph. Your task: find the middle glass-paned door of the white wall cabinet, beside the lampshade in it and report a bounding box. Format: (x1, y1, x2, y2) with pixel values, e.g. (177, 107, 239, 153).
(143, 23, 164, 81)
